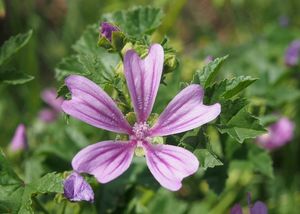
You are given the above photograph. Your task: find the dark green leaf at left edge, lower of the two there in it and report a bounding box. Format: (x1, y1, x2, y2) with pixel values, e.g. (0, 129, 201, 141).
(0, 68, 34, 85)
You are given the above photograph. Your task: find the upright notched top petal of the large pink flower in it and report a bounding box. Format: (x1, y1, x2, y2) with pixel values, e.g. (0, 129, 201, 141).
(124, 44, 164, 122)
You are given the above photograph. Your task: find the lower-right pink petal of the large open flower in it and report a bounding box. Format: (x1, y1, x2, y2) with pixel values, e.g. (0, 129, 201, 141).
(143, 142, 199, 191)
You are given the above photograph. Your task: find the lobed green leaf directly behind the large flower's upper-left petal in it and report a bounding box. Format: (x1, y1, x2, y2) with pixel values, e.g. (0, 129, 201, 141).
(55, 24, 120, 84)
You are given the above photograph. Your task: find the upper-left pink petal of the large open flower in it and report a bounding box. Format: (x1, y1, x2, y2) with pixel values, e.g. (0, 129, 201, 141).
(62, 75, 131, 134)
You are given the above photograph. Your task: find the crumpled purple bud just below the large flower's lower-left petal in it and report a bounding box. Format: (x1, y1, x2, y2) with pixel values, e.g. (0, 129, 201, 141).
(64, 172, 94, 202)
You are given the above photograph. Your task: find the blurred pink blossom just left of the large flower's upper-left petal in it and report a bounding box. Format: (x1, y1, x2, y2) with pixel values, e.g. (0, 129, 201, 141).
(39, 88, 64, 123)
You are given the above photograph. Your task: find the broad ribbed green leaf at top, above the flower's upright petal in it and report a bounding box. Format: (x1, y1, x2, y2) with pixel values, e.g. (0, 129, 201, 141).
(103, 6, 163, 37)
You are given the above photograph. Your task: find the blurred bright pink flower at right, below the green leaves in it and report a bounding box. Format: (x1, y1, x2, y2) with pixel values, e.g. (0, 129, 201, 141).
(257, 117, 294, 150)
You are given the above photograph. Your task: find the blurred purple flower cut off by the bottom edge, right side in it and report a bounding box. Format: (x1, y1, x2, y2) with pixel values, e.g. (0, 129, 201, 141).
(230, 193, 268, 214)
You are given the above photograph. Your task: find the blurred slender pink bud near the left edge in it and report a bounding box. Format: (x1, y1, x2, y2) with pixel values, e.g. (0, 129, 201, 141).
(10, 124, 28, 151)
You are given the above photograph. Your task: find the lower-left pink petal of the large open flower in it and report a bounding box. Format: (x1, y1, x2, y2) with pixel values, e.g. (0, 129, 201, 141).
(72, 141, 136, 183)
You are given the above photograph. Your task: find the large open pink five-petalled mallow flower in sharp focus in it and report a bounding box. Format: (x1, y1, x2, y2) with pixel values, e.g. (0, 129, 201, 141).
(62, 44, 221, 191)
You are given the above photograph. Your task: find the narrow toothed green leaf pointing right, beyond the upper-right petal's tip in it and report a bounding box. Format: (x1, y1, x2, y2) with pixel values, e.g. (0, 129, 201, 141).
(222, 76, 257, 99)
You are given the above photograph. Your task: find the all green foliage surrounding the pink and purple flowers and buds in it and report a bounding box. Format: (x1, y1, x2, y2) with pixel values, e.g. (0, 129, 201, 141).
(0, 0, 300, 214)
